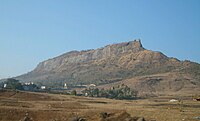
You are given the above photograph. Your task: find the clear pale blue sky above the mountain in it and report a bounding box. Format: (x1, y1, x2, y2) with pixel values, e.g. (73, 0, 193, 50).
(0, 0, 200, 78)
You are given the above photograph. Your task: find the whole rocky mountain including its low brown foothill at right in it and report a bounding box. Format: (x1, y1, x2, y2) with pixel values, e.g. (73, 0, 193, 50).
(16, 40, 200, 94)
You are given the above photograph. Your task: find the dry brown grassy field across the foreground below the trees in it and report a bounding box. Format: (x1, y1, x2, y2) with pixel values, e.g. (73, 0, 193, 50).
(0, 91, 200, 121)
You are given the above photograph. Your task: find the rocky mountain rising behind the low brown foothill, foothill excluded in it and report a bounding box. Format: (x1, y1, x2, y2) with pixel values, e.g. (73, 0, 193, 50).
(16, 40, 200, 96)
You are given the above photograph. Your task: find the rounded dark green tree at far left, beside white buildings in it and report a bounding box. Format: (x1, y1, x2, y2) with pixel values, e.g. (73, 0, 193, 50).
(5, 78, 23, 90)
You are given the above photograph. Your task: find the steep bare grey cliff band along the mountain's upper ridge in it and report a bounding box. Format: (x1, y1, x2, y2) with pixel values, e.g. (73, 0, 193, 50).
(34, 40, 144, 72)
